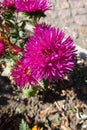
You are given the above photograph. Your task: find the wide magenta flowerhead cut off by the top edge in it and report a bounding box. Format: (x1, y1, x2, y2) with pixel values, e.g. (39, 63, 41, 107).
(16, 0, 51, 13)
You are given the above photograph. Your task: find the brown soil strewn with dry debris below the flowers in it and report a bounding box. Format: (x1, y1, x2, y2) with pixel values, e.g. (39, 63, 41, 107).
(0, 57, 87, 130)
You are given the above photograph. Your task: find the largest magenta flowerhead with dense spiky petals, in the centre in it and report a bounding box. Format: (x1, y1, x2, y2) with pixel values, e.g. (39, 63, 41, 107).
(24, 24, 76, 80)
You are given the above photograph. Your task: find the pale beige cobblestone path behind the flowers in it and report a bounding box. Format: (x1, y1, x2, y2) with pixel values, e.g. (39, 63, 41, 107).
(41, 0, 87, 50)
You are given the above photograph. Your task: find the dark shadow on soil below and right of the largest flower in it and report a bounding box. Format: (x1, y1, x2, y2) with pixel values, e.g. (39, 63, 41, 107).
(43, 59, 87, 104)
